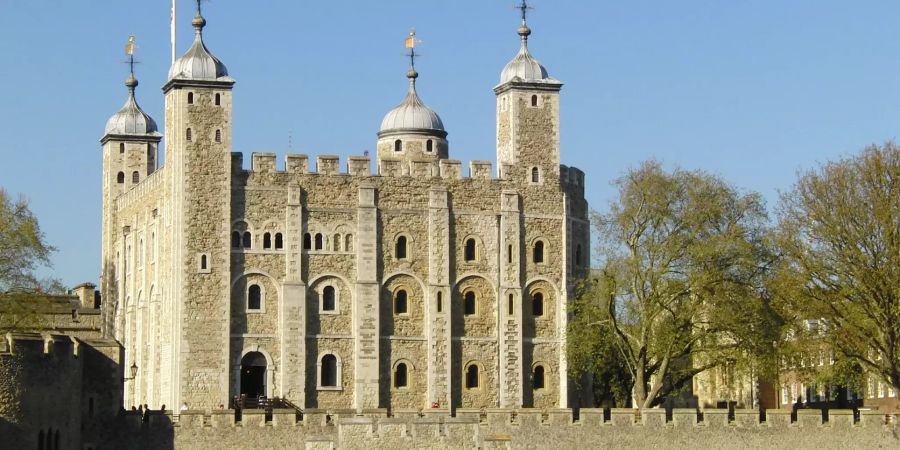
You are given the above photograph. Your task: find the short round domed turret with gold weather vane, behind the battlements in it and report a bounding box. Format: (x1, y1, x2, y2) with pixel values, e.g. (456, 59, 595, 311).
(377, 32, 449, 172)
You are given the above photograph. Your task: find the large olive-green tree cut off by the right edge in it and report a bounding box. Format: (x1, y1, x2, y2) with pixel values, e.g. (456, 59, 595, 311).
(777, 143, 900, 398)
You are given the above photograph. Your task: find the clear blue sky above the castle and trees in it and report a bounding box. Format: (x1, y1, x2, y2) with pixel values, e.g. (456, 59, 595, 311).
(0, 0, 900, 284)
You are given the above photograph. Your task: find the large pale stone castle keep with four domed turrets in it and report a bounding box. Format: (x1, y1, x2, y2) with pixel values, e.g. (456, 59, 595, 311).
(100, 2, 590, 411)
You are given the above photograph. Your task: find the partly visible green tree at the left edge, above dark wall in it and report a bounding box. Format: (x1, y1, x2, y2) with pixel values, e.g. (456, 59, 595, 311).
(0, 188, 55, 293)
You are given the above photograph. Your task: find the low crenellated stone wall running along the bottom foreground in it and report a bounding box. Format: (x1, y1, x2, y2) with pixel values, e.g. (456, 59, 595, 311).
(98, 409, 900, 450)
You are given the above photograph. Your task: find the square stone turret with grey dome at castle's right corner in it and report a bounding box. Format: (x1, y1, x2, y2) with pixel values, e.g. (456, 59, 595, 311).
(494, 1, 562, 184)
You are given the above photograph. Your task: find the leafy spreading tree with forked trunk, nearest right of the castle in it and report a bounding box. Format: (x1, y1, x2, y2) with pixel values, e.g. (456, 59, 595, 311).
(593, 161, 772, 408)
